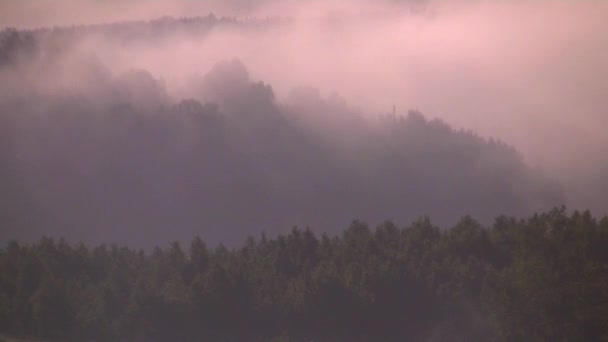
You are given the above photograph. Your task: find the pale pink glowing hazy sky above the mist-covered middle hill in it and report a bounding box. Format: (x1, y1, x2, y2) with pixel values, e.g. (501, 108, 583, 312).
(0, 0, 608, 212)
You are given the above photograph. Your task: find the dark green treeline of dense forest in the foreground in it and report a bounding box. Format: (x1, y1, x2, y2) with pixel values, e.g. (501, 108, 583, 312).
(0, 208, 608, 341)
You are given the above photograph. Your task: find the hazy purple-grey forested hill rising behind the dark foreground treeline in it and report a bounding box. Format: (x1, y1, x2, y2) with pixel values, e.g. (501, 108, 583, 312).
(0, 53, 563, 246)
